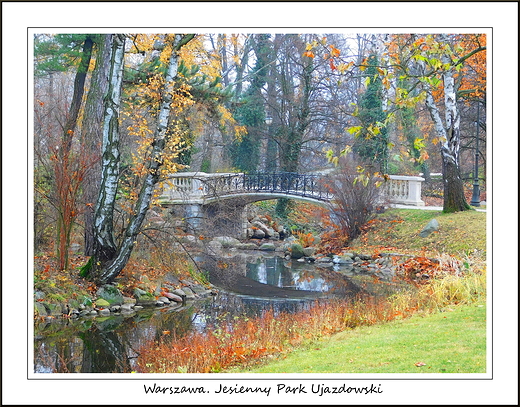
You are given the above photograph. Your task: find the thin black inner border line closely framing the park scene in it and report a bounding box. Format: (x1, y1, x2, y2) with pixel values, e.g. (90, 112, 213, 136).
(26, 27, 494, 382)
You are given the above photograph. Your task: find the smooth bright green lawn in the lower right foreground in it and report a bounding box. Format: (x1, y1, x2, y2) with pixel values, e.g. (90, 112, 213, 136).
(237, 303, 486, 373)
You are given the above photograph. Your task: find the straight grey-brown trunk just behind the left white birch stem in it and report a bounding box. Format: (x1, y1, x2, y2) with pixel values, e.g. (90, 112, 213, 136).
(81, 34, 113, 256)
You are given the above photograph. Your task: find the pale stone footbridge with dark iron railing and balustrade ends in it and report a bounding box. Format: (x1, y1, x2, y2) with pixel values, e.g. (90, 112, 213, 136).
(159, 172, 424, 236)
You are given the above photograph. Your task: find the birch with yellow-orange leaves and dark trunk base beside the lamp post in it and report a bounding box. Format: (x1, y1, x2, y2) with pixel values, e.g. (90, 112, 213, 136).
(338, 34, 486, 212)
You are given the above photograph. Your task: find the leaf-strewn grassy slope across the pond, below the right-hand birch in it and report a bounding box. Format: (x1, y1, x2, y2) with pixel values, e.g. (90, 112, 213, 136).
(350, 209, 486, 257)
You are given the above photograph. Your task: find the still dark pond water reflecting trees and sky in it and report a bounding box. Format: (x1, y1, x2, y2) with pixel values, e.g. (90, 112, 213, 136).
(34, 253, 406, 373)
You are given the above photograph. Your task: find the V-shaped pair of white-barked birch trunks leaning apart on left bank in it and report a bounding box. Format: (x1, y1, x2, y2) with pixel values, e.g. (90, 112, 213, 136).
(86, 34, 195, 284)
